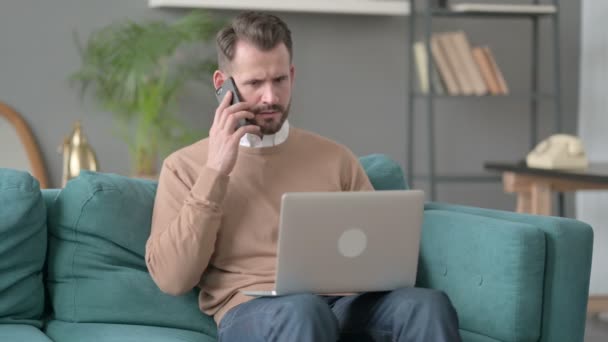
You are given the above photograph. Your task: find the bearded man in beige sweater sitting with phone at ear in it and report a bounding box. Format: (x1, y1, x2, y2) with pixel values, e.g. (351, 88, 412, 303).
(146, 12, 460, 342)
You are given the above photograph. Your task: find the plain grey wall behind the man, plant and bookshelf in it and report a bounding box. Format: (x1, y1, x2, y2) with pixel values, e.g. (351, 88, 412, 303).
(0, 0, 580, 214)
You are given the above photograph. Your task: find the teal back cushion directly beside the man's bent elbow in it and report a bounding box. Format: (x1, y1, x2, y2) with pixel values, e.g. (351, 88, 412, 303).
(47, 172, 216, 341)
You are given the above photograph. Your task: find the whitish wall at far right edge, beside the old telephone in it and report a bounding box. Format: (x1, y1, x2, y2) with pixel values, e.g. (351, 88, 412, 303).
(576, 0, 608, 294)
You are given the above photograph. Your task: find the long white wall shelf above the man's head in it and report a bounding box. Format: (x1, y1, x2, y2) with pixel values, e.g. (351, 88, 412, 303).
(148, 0, 410, 16)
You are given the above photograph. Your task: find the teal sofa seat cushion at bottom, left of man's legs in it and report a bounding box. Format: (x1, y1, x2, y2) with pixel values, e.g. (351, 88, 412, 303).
(46, 321, 216, 342)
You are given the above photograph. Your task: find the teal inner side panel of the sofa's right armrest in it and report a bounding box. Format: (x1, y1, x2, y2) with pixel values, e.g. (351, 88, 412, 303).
(417, 210, 545, 342)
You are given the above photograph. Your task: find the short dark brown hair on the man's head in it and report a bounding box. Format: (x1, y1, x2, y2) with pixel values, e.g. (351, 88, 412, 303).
(216, 11, 293, 71)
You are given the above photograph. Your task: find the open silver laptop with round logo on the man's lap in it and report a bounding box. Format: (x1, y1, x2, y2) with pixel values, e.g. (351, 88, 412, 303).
(243, 190, 424, 296)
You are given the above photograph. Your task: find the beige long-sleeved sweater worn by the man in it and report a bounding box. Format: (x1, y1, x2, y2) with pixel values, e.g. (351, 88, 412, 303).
(146, 128, 373, 324)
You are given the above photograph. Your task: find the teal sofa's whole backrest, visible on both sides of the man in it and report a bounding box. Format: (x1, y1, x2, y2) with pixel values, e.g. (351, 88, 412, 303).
(0, 154, 407, 336)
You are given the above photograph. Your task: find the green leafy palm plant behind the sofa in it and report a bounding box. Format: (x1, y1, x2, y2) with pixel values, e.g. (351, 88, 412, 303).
(70, 11, 222, 176)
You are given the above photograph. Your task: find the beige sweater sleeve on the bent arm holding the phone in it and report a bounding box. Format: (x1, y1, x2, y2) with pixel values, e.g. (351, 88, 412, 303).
(146, 162, 229, 295)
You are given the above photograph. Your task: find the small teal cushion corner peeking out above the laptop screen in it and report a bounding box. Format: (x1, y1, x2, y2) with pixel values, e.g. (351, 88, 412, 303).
(359, 154, 408, 190)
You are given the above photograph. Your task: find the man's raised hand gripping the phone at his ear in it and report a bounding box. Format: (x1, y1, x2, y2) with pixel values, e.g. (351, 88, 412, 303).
(207, 91, 260, 175)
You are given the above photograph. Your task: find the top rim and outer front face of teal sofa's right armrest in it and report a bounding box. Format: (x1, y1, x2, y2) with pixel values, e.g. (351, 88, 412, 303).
(425, 203, 593, 342)
